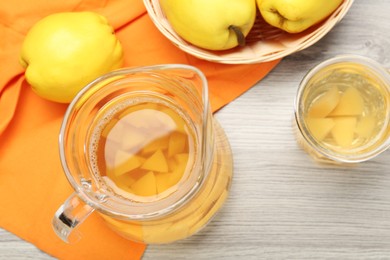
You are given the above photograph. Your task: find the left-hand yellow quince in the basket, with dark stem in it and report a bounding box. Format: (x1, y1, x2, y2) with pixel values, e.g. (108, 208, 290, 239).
(160, 0, 257, 50)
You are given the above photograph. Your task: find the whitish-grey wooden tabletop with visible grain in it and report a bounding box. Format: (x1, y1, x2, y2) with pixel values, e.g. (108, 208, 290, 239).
(0, 0, 390, 259)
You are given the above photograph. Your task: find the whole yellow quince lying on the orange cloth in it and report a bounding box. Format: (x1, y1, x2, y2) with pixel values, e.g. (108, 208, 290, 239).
(20, 12, 123, 103)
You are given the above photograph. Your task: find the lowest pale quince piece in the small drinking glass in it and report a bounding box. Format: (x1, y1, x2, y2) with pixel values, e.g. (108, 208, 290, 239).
(331, 117, 357, 148)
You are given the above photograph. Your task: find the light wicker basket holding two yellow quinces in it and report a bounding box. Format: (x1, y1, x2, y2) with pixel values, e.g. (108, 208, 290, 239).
(144, 0, 354, 64)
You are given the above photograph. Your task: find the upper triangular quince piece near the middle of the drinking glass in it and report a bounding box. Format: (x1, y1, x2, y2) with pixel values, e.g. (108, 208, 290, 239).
(329, 87, 364, 116)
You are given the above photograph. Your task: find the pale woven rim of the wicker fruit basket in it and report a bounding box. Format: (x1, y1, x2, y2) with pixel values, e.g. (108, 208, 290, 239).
(143, 0, 354, 64)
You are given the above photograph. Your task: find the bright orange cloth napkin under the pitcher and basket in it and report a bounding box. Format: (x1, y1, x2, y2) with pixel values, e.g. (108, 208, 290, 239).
(0, 0, 278, 259)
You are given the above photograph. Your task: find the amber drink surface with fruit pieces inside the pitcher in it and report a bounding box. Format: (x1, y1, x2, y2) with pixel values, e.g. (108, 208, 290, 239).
(97, 103, 193, 196)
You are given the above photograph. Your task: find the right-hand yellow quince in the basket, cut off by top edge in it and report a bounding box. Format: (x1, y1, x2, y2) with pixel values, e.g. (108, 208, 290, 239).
(256, 0, 343, 33)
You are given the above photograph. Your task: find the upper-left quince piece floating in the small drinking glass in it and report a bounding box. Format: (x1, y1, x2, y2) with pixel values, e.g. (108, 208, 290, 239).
(308, 86, 340, 118)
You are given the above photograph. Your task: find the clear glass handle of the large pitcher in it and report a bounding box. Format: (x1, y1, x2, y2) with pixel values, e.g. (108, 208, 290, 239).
(52, 193, 94, 243)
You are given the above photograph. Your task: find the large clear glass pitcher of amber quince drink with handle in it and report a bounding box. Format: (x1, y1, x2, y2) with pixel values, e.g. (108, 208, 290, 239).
(52, 64, 233, 244)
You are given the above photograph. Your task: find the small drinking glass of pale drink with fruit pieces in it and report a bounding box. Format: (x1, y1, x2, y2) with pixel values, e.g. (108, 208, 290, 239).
(295, 55, 390, 163)
